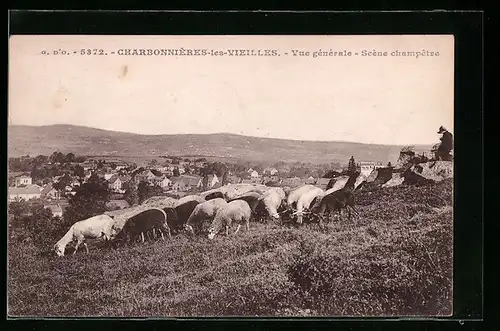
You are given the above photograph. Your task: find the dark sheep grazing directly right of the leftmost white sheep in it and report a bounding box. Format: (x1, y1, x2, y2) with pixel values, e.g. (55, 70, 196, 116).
(115, 208, 171, 242)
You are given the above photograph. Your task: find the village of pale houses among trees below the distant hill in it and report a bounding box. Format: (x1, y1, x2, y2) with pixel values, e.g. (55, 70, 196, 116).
(8, 152, 390, 217)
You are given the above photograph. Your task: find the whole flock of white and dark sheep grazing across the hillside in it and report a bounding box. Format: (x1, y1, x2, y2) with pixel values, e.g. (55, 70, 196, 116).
(54, 173, 366, 256)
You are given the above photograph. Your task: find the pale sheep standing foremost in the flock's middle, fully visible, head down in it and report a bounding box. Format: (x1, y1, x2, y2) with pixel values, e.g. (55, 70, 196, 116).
(208, 200, 252, 240)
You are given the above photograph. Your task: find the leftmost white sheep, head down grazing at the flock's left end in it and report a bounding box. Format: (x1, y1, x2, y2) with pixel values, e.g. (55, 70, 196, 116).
(54, 215, 116, 256)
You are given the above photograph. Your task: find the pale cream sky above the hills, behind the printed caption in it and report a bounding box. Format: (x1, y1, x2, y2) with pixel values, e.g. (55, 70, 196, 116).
(8, 35, 454, 145)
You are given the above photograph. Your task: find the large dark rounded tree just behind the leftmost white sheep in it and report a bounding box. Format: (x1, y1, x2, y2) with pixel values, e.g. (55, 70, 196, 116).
(64, 175, 110, 223)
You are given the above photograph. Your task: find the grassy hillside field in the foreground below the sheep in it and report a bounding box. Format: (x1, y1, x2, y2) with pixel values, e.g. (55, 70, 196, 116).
(8, 180, 453, 316)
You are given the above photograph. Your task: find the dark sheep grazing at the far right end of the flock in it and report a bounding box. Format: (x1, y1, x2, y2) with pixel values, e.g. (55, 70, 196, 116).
(311, 189, 358, 223)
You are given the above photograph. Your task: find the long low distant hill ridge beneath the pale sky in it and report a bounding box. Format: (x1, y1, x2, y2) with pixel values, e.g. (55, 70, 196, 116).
(8, 125, 431, 164)
